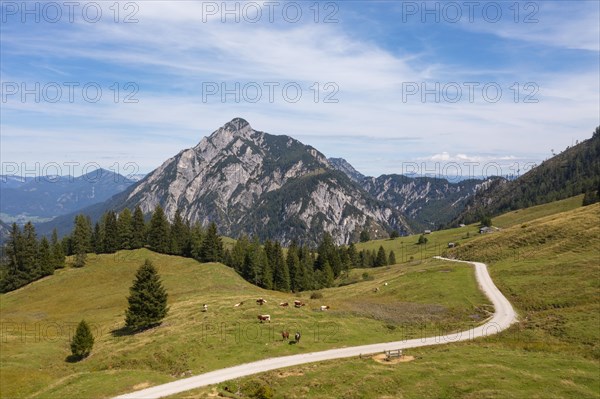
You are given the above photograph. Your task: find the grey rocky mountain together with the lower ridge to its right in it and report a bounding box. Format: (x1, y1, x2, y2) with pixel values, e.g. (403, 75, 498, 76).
(38, 118, 502, 244)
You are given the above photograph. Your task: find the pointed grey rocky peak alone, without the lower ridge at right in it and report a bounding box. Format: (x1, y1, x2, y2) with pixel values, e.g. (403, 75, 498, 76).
(117, 118, 409, 244)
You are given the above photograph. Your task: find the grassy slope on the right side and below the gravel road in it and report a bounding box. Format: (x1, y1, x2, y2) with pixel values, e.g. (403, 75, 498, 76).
(176, 201, 600, 399)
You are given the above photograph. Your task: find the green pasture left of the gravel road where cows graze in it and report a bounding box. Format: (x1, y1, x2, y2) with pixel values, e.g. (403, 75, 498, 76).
(0, 250, 488, 399)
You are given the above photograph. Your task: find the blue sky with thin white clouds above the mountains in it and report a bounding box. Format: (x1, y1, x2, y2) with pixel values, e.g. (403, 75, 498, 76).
(0, 0, 600, 175)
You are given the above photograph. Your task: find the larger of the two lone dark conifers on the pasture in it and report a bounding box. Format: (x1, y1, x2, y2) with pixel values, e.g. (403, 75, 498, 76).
(125, 259, 169, 331)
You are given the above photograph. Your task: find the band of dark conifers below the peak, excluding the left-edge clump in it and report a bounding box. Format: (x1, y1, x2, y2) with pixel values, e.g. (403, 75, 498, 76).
(64, 206, 396, 291)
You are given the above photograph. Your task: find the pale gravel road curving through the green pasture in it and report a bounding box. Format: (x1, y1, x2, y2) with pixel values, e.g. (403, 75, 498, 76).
(115, 256, 517, 399)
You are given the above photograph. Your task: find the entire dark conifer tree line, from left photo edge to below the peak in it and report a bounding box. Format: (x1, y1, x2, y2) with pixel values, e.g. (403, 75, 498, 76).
(0, 206, 396, 292)
